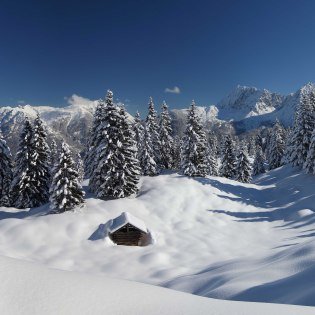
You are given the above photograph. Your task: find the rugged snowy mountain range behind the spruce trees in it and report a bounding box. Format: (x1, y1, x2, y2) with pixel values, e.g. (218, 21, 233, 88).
(0, 83, 315, 152)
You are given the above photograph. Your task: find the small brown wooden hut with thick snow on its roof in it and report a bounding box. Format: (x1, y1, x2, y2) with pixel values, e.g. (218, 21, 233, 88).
(108, 212, 150, 246)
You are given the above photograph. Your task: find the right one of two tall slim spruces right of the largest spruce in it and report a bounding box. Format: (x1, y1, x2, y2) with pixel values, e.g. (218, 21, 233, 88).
(159, 101, 174, 169)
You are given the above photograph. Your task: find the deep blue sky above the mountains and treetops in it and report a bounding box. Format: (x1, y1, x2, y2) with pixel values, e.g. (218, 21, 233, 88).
(0, 0, 315, 112)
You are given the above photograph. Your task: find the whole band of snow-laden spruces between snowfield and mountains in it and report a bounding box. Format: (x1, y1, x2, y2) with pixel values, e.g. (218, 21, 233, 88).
(0, 91, 315, 212)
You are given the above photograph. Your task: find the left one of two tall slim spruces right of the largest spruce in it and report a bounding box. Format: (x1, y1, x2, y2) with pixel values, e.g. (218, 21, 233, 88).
(146, 97, 161, 165)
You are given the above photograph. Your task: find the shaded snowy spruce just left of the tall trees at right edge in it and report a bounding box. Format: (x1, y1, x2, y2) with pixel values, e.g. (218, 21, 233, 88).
(268, 120, 285, 170)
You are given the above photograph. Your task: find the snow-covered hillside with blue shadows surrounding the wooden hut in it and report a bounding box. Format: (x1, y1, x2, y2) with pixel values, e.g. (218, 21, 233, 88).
(0, 167, 315, 312)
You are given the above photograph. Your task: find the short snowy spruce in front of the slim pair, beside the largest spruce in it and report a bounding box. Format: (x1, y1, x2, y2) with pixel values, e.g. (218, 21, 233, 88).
(140, 124, 160, 176)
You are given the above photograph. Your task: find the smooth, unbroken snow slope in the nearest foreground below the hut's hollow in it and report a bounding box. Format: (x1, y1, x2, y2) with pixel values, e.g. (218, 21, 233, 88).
(0, 257, 313, 315)
